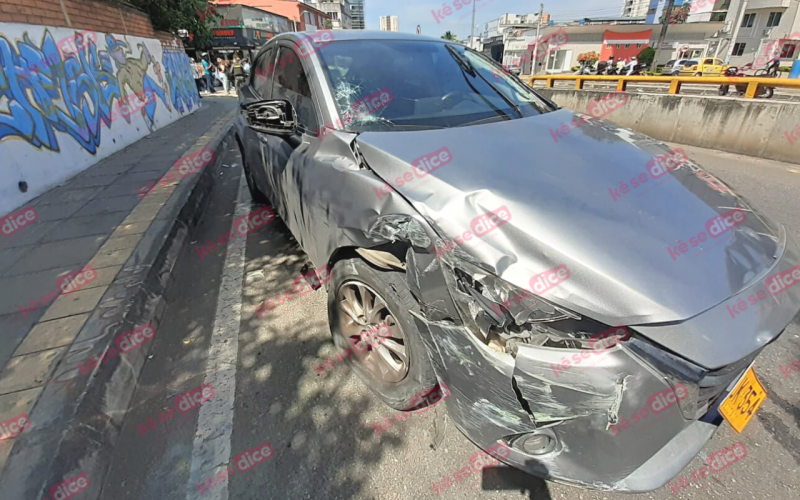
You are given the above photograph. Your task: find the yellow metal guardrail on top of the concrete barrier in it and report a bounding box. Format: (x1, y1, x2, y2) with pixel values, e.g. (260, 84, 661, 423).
(528, 75, 800, 99)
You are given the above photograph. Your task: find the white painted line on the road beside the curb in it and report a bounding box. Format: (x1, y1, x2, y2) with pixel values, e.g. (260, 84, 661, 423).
(186, 173, 250, 500)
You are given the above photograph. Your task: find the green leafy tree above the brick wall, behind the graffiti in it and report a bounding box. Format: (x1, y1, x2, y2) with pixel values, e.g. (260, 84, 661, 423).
(129, 0, 220, 49)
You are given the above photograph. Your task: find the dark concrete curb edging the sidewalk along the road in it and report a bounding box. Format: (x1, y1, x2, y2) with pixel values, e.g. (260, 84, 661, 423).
(0, 113, 234, 499)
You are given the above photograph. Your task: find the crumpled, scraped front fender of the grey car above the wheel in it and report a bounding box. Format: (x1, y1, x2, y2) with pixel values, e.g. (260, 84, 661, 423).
(260, 132, 434, 267)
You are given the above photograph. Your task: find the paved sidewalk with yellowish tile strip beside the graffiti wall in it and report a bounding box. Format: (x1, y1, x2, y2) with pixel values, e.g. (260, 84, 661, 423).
(0, 96, 238, 498)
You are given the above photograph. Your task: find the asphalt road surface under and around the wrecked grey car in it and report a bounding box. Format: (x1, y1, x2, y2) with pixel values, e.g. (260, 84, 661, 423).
(97, 139, 800, 500)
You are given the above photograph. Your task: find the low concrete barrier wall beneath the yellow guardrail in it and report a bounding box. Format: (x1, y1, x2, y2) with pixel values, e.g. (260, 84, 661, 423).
(536, 88, 800, 163)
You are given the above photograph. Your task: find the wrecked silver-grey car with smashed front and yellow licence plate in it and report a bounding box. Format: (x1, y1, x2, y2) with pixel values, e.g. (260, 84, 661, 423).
(235, 30, 800, 491)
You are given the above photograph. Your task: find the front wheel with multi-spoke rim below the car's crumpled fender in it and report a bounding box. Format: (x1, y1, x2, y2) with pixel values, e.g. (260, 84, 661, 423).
(328, 258, 437, 410)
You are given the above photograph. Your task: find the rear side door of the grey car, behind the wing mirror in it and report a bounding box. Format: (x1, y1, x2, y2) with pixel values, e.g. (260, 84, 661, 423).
(241, 44, 277, 200)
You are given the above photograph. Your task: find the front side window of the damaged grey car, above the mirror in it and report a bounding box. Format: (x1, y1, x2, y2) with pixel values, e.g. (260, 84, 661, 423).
(271, 47, 319, 131)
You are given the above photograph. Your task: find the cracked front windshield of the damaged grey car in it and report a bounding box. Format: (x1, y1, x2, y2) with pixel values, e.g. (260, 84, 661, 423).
(318, 40, 551, 131)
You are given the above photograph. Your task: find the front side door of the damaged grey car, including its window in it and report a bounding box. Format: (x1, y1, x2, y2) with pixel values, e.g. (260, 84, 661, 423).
(266, 42, 322, 253)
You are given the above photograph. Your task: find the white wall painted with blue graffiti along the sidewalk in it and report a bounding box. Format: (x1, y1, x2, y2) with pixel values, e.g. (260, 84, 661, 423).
(0, 23, 200, 215)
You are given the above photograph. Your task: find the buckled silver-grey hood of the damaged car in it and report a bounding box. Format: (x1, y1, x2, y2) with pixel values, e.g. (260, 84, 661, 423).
(357, 110, 781, 325)
